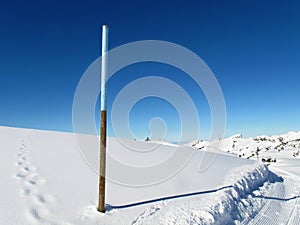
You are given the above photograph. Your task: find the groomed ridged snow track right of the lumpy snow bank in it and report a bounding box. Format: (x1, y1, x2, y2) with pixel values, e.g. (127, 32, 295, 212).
(241, 171, 300, 225)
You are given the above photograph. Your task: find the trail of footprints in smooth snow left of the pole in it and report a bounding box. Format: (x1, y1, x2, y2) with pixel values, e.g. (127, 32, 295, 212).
(13, 130, 68, 225)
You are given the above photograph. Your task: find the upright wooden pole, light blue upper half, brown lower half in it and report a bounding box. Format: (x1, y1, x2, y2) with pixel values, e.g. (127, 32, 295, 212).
(97, 25, 108, 213)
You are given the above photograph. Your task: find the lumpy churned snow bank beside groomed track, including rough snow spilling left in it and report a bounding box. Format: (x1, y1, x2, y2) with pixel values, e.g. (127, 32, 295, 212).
(125, 164, 270, 225)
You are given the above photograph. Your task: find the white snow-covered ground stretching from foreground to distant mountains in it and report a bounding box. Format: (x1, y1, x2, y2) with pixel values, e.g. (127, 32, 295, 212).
(0, 127, 300, 225)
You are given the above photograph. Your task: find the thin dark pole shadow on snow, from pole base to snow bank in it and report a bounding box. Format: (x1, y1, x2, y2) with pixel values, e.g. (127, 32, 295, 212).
(107, 185, 233, 210)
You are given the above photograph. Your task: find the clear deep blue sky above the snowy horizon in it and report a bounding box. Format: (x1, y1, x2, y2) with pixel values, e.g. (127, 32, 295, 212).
(0, 0, 300, 140)
